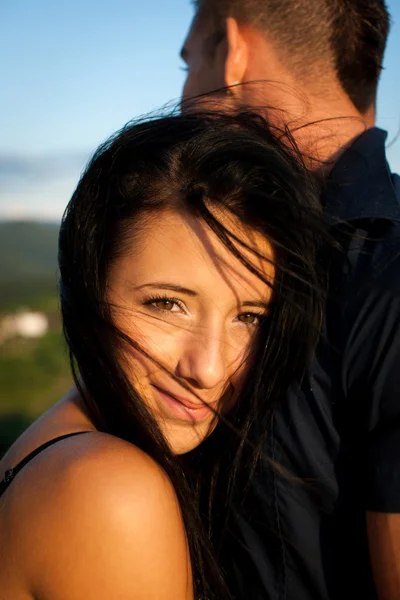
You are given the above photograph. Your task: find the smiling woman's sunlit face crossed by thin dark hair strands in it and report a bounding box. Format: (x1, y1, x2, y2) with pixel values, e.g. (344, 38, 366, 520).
(108, 211, 274, 454)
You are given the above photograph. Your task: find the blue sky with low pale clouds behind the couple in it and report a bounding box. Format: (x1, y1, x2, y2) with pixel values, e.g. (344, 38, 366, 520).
(0, 0, 400, 220)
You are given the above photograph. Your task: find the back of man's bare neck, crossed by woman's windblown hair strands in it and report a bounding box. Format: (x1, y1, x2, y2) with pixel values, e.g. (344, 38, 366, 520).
(240, 56, 375, 170)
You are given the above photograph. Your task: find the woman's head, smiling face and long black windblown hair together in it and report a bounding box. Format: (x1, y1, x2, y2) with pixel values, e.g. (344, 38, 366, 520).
(59, 112, 325, 599)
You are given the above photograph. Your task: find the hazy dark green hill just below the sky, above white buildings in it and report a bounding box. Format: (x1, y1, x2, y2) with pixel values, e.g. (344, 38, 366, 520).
(0, 221, 59, 309)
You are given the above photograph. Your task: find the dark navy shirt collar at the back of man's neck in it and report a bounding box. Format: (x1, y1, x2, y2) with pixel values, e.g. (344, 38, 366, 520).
(325, 127, 400, 221)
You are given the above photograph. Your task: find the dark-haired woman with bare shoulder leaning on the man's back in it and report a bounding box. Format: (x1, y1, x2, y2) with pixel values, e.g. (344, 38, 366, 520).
(0, 113, 324, 600)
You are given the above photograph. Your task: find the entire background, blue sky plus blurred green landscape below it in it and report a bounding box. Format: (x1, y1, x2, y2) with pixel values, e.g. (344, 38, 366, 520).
(0, 0, 400, 455)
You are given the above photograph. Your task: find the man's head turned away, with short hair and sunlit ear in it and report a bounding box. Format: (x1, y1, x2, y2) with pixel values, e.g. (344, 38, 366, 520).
(182, 0, 389, 115)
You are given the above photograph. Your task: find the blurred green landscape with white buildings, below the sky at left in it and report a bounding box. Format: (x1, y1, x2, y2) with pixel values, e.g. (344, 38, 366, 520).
(0, 221, 71, 455)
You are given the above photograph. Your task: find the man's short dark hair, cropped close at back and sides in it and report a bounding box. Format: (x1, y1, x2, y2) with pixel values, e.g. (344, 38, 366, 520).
(194, 0, 390, 113)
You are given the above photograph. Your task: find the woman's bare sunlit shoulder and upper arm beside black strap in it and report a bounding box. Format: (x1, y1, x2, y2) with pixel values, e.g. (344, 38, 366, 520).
(6, 432, 192, 600)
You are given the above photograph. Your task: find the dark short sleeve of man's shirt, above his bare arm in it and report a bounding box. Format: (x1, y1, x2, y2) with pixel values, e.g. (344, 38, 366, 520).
(343, 274, 400, 513)
